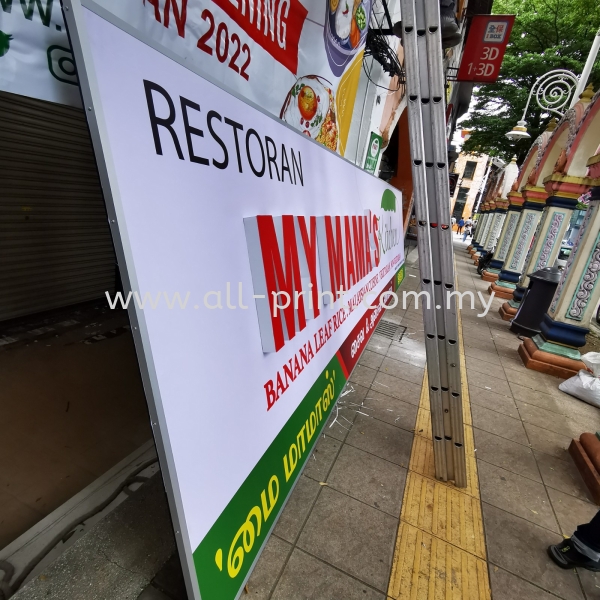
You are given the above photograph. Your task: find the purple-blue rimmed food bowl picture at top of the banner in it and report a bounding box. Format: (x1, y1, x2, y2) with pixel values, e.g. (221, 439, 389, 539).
(324, 0, 371, 77)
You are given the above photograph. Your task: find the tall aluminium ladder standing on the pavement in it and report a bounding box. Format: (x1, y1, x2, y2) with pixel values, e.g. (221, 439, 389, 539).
(401, 0, 467, 487)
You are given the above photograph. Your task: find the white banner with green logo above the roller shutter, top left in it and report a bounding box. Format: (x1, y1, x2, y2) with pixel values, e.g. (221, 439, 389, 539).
(0, 0, 81, 106)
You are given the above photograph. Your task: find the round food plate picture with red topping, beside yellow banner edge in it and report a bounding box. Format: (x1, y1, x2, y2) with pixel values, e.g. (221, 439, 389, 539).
(279, 74, 343, 151)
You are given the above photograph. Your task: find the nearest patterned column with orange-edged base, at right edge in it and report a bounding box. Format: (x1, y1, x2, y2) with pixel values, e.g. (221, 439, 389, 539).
(519, 185, 600, 378)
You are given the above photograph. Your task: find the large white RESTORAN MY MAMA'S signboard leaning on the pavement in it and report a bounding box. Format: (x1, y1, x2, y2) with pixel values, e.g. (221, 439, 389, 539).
(65, 0, 404, 600)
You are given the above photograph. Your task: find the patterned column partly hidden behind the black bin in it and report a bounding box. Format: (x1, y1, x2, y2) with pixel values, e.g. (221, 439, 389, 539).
(499, 173, 593, 321)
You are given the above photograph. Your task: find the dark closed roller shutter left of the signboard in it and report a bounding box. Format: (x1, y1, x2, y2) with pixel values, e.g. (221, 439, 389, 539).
(0, 92, 115, 321)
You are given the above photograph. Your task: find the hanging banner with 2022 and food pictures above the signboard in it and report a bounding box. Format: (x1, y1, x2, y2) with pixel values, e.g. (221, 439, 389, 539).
(74, 0, 373, 155)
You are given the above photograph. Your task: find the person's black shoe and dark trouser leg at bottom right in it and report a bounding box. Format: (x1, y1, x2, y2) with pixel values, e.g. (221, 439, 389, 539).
(548, 511, 600, 571)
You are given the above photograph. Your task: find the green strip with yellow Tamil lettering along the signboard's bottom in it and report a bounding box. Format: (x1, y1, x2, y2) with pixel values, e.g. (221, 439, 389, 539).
(194, 355, 346, 600)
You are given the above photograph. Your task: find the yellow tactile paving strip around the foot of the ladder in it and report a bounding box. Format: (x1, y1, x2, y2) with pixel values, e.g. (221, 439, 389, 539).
(388, 317, 491, 600)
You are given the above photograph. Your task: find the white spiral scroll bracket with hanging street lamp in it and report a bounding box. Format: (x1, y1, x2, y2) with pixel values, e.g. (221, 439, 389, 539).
(506, 69, 579, 142)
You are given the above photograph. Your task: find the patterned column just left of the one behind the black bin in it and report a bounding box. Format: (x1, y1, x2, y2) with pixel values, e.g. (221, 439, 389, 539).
(488, 185, 548, 300)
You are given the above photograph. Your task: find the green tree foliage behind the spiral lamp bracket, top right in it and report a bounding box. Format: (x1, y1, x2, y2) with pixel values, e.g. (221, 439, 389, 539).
(461, 0, 600, 164)
